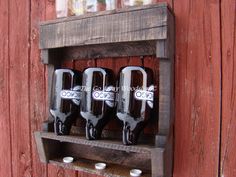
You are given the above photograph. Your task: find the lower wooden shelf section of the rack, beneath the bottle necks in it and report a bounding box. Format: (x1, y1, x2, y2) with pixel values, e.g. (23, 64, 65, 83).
(35, 132, 172, 177)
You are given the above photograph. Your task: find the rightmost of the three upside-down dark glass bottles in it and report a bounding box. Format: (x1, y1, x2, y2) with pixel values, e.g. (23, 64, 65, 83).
(116, 66, 154, 145)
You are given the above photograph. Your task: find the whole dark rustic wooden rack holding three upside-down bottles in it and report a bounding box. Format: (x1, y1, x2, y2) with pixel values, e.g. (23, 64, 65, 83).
(35, 3, 175, 177)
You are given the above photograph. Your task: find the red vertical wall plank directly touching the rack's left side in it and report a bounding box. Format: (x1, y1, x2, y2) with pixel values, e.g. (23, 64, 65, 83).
(29, 0, 47, 177)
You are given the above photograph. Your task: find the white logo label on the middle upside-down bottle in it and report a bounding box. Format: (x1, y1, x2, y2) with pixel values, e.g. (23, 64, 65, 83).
(92, 86, 115, 107)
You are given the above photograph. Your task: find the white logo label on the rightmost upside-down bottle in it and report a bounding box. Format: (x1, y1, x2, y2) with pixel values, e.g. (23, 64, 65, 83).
(134, 85, 154, 108)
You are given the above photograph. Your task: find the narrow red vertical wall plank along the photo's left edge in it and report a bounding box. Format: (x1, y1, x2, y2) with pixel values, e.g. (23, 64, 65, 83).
(0, 0, 12, 177)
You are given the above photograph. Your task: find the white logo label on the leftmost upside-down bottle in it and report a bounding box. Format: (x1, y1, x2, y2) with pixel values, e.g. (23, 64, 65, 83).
(60, 86, 81, 105)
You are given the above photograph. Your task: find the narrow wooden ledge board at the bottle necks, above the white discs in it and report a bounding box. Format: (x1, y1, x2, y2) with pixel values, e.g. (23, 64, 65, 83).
(36, 132, 164, 154)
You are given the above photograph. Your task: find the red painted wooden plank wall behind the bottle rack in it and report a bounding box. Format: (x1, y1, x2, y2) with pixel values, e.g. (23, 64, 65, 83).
(0, 0, 236, 177)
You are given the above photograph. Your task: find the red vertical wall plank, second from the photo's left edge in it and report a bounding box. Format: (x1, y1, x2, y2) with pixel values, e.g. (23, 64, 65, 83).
(9, 0, 32, 177)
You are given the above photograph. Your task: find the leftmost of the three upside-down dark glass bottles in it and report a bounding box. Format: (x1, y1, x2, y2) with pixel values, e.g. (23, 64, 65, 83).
(50, 69, 81, 135)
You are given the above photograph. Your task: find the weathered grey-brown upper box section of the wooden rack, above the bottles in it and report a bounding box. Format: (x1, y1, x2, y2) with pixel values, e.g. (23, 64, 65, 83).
(40, 4, 172, 63)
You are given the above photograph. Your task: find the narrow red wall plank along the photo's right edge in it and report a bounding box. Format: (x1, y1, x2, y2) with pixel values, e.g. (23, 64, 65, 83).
(220, 0, 236, 177)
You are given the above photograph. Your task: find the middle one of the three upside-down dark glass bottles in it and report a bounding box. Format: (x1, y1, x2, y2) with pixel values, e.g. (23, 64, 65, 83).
(80, 68, 115, 140)
